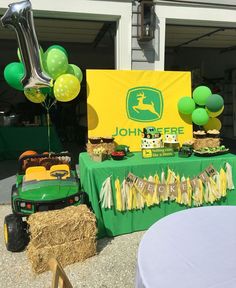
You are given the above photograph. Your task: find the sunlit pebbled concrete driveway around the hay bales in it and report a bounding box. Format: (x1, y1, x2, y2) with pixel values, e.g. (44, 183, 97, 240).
(0, 205, 144, 288)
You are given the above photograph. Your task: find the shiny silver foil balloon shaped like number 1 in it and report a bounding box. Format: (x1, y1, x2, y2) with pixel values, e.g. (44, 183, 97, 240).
(1, 0, 52, 89)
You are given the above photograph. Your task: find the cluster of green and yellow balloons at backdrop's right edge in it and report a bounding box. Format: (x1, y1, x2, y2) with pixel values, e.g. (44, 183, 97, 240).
(178, 86, 224, 130)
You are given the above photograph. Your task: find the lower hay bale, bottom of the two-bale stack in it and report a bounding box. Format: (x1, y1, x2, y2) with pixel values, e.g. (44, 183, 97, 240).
(27, 238, 96, 274)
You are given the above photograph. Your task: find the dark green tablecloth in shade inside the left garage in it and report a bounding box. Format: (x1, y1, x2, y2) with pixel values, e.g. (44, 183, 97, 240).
(0, 126, 63, 160)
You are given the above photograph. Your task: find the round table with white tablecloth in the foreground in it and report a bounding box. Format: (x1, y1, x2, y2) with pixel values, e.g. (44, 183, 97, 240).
(136, 206, 236, 288)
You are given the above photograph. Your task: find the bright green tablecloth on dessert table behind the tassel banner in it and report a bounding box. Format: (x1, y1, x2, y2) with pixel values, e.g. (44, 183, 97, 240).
(79, 153, 236, 237)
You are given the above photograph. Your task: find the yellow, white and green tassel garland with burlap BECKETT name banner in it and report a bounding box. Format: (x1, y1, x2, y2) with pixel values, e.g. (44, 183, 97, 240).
(100, 163, 234, 211)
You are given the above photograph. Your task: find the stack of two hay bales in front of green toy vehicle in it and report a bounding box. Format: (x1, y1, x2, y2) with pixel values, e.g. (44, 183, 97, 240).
(27, 205, 97, 273)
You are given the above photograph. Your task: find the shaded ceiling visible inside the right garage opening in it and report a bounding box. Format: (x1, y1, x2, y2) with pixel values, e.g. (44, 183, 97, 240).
(166, 25, 236, 49)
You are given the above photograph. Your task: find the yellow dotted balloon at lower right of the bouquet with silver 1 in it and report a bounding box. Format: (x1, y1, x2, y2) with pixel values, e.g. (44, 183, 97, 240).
(53, 74, 80, 102)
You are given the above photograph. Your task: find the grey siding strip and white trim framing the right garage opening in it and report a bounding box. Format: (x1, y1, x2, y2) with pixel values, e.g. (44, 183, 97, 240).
(132, 0, 236, 70)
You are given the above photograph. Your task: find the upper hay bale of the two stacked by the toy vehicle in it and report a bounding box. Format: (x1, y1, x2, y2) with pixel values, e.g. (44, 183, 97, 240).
(27, 205, 97, 248)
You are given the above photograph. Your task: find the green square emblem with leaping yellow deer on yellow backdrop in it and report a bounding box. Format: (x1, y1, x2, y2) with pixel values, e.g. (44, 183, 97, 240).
(126, 87, 163, 122)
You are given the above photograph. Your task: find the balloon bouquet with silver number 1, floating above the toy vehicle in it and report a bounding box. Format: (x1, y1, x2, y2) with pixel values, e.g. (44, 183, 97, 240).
(1, 0, 83, 152)
